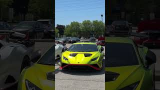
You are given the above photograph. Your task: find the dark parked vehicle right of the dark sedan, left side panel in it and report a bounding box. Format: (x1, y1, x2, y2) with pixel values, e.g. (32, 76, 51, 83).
(37, 19, 55, 38)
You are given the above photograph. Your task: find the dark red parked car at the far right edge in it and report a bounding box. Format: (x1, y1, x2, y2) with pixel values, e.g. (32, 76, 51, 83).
(134, 19, 160, 48)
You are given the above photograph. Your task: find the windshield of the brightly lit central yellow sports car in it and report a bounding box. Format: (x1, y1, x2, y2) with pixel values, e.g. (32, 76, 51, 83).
(68, 44, 98, 52)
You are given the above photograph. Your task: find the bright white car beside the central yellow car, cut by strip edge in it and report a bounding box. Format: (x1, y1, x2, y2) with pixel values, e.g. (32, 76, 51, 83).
(55, 44, 66, 59)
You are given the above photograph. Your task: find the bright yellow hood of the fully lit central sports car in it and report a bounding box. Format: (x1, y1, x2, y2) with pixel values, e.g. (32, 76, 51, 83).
(62, 51, 100, 64)
